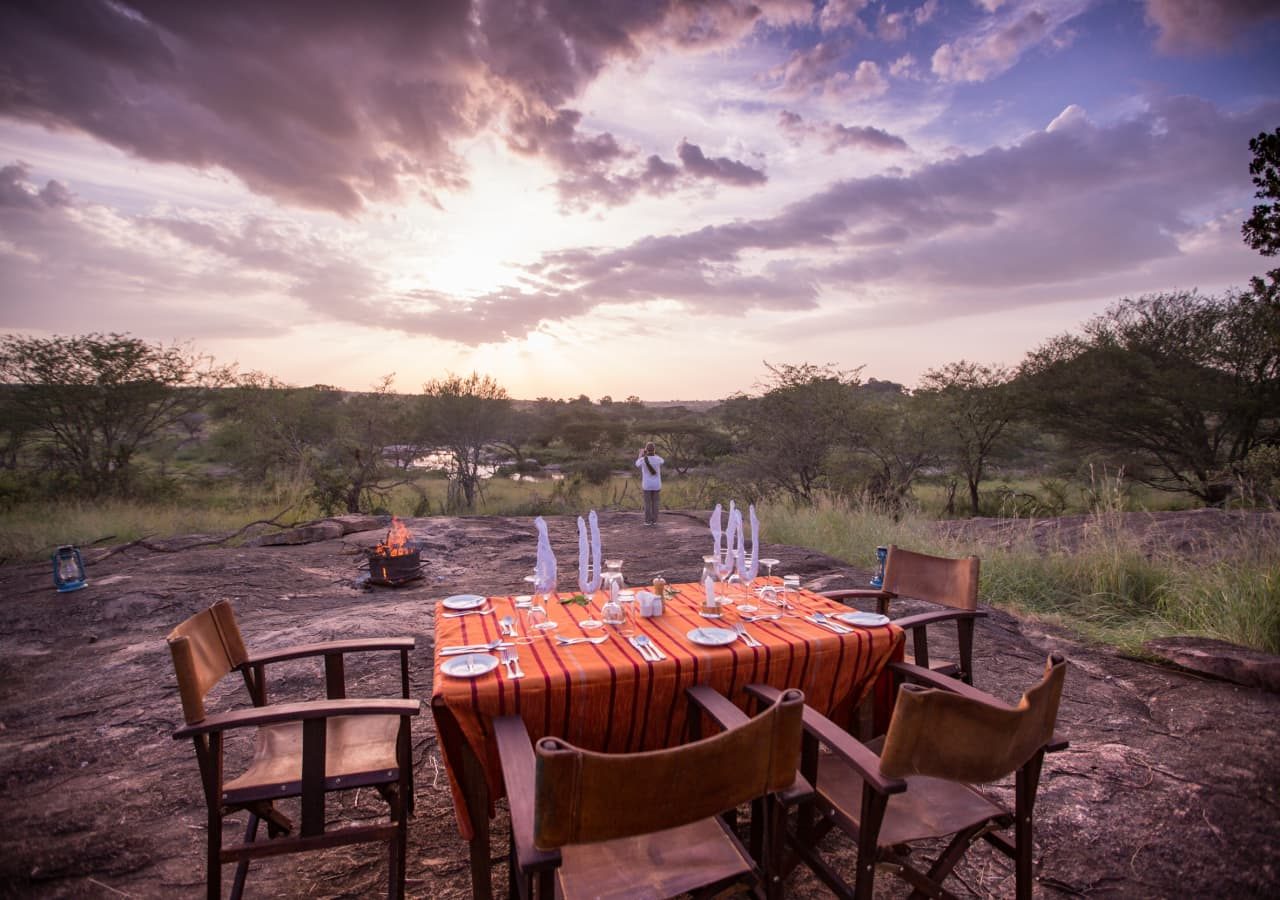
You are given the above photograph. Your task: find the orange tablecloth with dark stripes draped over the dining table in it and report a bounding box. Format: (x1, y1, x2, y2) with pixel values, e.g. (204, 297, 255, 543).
(431, 584, 902, 840)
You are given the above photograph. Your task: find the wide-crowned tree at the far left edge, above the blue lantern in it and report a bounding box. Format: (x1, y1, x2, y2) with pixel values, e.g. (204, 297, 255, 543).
(0, 334, 232, 497)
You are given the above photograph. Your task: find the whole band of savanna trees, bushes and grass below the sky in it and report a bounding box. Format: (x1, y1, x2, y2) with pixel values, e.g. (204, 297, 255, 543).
(0, 129, 1280, 652)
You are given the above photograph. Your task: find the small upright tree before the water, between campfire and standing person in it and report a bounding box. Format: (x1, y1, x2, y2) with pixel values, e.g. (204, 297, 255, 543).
(422, 373, 512, 510)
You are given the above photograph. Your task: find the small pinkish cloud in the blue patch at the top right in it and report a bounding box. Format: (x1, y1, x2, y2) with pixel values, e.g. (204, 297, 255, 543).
(932, 0, 1089, 82)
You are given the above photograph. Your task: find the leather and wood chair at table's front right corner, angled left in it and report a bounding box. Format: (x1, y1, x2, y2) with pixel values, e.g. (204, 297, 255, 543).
(746, 654, 1066, 900)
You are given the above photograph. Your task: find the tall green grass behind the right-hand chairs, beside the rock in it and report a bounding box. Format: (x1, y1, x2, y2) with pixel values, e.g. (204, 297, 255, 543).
(762, 491, 1280, 653)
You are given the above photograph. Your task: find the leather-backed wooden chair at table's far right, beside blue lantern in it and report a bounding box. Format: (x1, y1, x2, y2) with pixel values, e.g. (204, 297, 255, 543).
(823, 545, 987, 685)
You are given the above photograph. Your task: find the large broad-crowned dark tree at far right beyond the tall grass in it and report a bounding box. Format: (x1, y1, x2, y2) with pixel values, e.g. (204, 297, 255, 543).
(1020, 292, 1280, 506)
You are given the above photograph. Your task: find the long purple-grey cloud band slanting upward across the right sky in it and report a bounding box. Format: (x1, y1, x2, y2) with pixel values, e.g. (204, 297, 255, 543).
(476, 97, 1280, 337)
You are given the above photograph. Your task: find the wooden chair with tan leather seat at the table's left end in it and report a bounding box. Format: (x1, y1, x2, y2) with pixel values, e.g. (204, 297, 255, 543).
(169, 602, 420, 900)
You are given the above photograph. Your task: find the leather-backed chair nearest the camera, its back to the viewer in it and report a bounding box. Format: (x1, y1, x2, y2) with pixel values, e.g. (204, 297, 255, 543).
(494, 690, 804, 900)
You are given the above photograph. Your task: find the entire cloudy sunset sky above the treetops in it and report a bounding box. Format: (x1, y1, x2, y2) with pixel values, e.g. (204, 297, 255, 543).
(0, 0, 1280, 401)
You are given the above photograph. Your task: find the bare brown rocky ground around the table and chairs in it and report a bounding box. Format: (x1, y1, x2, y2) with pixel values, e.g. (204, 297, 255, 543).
(0, 513, 1280, 897)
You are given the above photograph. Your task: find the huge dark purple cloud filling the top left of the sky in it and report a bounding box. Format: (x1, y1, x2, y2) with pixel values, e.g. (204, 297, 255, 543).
(0, 0, 812, 215)
